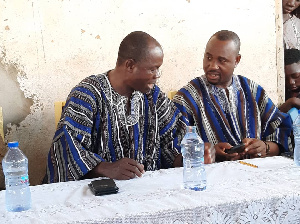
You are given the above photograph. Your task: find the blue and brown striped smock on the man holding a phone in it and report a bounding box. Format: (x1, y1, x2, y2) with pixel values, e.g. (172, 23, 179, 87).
(173, 75, 292, 151)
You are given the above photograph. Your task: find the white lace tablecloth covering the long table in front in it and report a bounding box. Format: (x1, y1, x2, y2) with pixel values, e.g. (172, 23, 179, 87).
(0, 157, 300, 224)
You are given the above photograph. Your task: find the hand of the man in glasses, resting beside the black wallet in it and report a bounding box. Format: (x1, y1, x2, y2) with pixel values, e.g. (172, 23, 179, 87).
(91, 158, 145, 180)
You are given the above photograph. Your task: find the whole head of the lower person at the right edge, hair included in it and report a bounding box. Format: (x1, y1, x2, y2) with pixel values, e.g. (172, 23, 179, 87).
(284, 49, 300, 96)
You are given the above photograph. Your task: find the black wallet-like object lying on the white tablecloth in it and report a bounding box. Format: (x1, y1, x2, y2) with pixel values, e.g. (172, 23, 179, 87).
(88, 179, 119, 196)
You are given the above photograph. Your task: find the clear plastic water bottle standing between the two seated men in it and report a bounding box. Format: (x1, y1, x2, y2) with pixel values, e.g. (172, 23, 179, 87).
(181, 126, 206, 191)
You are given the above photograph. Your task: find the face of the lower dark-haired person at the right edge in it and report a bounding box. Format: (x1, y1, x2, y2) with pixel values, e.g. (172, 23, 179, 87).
(284, 62, 300, 95)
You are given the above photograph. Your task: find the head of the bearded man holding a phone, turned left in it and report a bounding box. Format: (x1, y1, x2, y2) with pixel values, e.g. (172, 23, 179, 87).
(203, 30, 241, 88)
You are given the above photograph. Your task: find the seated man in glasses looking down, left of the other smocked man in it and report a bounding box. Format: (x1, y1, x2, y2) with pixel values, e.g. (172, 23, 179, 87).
(43, 31, 214, 183)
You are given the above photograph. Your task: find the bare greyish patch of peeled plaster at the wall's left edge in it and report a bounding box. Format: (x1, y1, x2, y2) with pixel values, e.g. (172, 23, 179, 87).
(0, 58, 33, 135)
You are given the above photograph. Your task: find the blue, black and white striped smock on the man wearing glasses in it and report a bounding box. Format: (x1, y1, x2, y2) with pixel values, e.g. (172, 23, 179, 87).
(43, 73, 185, 183)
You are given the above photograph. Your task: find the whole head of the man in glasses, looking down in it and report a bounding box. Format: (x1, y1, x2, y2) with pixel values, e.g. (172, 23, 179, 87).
(117, 31, 163, 93)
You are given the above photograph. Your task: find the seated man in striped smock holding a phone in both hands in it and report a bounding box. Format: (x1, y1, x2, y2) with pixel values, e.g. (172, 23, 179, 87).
(173, 30, 291, 161)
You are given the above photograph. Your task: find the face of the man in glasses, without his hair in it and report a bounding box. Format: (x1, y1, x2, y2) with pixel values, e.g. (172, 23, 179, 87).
(129, 44, 164, 93)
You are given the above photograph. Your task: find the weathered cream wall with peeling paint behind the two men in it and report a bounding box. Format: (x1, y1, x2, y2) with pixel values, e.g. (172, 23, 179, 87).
(0, 0, 280, 185)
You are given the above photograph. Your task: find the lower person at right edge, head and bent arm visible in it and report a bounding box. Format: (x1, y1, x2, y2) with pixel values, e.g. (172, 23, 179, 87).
(279, 49, 300, 119)
